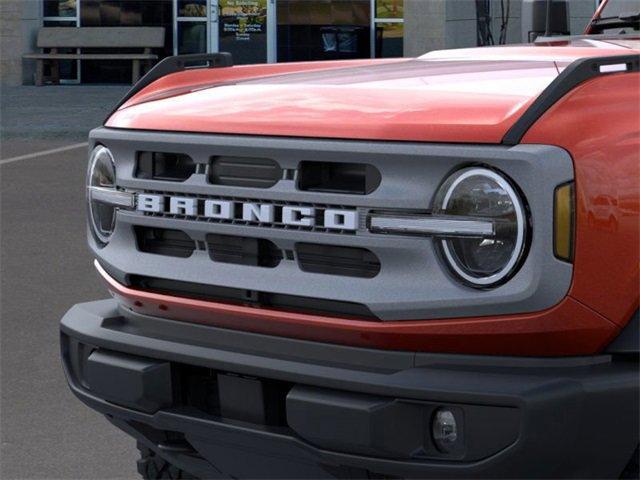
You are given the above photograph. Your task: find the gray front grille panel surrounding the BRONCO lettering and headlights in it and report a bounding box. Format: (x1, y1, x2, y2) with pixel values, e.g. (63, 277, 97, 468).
(89, 128, 573, 321)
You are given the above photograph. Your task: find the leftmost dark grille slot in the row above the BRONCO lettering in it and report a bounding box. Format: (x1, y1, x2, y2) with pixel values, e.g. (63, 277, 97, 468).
(136, 152, 196, 182)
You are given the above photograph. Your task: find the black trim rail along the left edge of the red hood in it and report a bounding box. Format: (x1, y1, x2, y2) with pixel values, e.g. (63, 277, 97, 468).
(105, 52, 233, 122)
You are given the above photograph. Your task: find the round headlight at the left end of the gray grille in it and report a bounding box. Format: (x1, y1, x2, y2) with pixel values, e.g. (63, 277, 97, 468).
(87, 145, 116, 243)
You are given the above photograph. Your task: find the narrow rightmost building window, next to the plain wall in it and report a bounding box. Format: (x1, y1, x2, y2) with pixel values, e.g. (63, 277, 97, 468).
(372, 0, 404, 58)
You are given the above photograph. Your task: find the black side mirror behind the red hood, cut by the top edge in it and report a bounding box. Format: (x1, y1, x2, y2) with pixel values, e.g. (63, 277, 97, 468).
(522, 0, 570, 43)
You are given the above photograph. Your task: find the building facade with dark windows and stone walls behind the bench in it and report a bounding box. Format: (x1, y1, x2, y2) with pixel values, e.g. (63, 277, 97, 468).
(0, 0, 597, 84)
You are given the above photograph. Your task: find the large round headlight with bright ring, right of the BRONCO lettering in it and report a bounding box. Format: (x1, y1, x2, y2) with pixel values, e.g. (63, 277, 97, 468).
(436, 167, 527, 288)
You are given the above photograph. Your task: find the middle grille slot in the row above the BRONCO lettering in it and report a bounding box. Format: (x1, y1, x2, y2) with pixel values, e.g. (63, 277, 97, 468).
(209, 156, 282, 188)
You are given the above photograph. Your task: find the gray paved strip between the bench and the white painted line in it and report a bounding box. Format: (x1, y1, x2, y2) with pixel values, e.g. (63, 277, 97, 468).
(0, 85, 130, 158)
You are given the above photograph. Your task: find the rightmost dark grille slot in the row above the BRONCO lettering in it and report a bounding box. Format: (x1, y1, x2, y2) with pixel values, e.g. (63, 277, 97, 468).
(298, 161, 382, 195)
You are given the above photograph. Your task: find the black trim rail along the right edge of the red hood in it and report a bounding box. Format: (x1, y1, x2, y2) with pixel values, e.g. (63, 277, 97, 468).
(502, 55, 640, 145)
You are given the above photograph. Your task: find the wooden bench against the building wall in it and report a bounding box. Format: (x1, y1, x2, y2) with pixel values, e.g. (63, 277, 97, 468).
(23, 27, 164, 85)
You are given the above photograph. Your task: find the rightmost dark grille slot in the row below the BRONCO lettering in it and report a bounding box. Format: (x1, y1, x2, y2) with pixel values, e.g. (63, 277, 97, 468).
(296, 243, 380, 278)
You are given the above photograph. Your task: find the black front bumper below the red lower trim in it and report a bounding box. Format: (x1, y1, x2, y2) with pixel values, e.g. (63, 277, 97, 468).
(61, 300, 639, 478)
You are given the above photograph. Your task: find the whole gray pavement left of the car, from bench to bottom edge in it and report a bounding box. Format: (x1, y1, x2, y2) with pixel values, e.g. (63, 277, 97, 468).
(0, 87, 138, 479)
